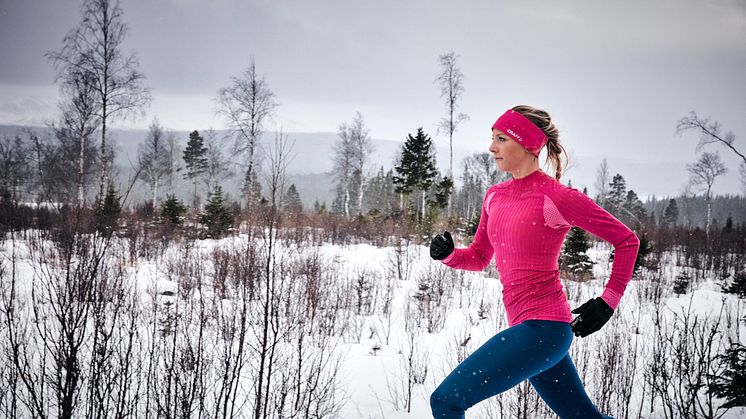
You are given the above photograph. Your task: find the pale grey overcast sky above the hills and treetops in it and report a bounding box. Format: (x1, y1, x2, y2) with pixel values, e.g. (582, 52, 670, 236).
(0, 0, 746, 193)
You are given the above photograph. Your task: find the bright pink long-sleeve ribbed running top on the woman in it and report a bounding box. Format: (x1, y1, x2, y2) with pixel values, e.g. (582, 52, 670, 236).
(442, 170, 640, 326)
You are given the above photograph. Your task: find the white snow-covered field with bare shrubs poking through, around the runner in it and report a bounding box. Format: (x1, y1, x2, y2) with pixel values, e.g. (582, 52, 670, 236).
(0, 231, 746, 419)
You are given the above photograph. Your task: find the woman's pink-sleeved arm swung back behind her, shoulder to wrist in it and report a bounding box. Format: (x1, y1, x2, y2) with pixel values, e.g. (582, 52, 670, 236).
(553, 187, 640, 310)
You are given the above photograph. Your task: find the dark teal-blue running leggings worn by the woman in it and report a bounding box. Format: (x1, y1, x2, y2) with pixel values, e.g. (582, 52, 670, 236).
(430, 320, 611, 419)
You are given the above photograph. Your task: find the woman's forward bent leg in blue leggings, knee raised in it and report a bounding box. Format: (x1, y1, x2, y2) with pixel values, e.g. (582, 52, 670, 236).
(430, 320, 572, 419)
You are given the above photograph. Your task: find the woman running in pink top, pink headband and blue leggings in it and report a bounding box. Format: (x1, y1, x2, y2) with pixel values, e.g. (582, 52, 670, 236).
(430, 105, 640, 419)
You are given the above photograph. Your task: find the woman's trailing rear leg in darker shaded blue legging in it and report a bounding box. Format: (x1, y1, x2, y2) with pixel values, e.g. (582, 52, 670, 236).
(529, 353, 613, 419)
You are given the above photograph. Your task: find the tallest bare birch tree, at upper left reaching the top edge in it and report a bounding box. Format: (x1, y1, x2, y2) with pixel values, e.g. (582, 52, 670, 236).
(47, 0, 151, 196)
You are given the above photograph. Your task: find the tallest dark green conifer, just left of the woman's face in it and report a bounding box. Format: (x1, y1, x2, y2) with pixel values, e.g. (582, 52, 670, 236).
(393, 127, 438, 220)
